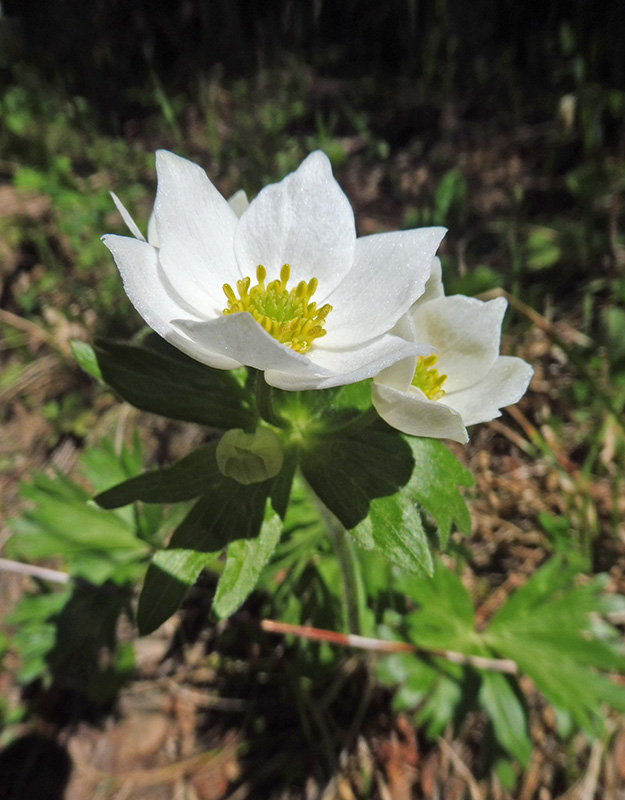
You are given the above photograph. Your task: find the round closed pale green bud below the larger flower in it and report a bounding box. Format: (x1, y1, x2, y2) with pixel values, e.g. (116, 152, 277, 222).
(216, 428, 284, 486)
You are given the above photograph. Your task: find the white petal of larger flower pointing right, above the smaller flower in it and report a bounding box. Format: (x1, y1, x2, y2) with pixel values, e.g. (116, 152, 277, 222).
(322, 228, 445, 349)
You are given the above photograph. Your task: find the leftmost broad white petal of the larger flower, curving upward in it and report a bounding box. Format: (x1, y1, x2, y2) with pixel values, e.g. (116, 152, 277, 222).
(102, 234, 240, 369)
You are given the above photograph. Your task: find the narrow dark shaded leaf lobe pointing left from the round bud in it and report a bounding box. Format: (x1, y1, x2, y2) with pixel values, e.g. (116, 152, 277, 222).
(94, 442, 223, 508)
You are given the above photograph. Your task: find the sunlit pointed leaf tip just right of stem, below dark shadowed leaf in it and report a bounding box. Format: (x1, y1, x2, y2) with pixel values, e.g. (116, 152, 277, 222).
(349, 492, 433, 575)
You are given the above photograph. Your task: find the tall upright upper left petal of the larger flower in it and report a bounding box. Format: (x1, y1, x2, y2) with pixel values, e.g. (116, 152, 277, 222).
(154, 150, 238, 314)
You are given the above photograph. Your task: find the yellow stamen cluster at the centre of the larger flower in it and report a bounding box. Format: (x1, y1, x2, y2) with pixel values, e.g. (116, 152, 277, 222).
(223, 264, 332, 353)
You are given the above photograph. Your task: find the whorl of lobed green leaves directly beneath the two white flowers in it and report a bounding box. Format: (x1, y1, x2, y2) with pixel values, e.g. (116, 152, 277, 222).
(85, 343, 470, 633)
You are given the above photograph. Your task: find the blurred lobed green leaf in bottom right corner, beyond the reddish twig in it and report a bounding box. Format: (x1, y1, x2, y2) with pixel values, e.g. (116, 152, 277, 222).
(377, 557, 625, 766)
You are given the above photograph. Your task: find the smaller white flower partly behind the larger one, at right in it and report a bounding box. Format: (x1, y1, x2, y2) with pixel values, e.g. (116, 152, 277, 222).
(372, 259, 533, 443)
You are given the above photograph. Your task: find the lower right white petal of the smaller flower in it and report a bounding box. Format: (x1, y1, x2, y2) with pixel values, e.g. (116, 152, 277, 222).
(439, 356, 534, 425)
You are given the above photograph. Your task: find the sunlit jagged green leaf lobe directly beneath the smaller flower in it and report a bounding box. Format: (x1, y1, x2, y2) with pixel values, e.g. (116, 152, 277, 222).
(405, 436, 474, 548)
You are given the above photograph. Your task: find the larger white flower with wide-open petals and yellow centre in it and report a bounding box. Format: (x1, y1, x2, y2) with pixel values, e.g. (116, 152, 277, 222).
(103, 150, 445, 390)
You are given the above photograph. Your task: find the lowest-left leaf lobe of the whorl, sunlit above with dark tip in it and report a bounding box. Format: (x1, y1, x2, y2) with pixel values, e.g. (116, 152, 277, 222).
(137, 549, 219, 636)
